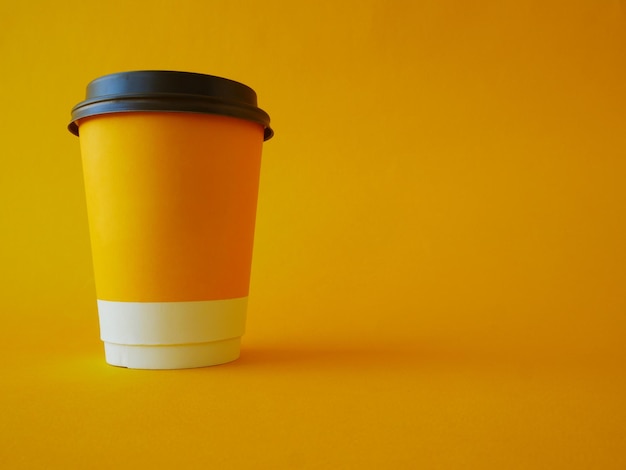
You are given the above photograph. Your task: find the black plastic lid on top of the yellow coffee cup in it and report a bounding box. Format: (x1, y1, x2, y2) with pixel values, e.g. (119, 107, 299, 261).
(68, 70, 274, 140)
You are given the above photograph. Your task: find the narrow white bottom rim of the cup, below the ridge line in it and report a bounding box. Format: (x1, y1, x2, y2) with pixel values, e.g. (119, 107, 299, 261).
(104, 338, 241, 369)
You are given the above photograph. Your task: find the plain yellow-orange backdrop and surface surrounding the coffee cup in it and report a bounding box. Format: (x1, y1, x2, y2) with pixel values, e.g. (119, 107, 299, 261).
(0, 0, 626, 469)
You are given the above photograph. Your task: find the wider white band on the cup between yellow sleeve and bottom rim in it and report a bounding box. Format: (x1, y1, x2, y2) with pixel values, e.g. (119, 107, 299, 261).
(98, 297, 248, 345)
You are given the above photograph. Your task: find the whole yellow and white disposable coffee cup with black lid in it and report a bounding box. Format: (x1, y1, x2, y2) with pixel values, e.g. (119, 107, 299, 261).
(68, 71, 273, 369)
